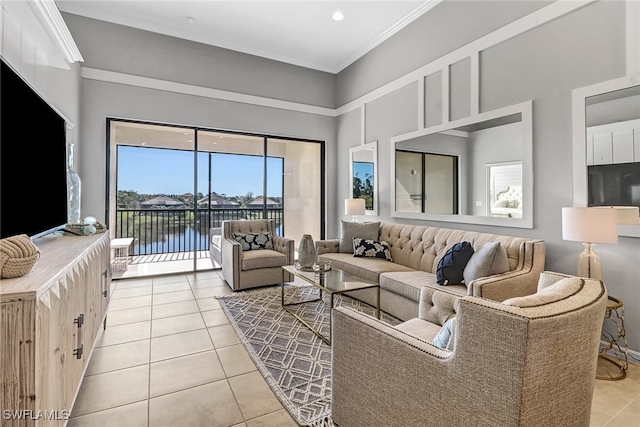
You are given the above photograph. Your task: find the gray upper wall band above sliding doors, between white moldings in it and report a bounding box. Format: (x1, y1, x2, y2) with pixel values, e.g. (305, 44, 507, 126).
(62, 13, 335, 108)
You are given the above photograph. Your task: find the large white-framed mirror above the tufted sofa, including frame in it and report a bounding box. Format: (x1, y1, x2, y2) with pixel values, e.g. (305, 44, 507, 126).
(391, 102, 533, 228)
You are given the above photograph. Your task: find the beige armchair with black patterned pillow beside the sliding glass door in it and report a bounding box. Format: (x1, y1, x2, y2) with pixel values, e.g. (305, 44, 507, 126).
(221, 219, 294, 291)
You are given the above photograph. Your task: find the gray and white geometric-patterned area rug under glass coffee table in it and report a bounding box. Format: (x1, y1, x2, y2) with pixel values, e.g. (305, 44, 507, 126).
(217, 285, 400, 427)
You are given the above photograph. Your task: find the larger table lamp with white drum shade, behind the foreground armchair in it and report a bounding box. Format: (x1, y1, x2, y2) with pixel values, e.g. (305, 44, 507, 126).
(562, 207, 618, 280)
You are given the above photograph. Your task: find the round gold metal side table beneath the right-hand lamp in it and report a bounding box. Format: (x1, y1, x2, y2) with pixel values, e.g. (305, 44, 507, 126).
(596, 296, 629, 381)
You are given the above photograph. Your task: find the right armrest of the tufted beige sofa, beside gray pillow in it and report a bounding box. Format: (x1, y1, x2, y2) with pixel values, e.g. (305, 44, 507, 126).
(467, 240, 545, 301)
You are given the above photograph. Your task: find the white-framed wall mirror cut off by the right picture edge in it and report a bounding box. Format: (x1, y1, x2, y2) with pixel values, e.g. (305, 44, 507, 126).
(573, 74, 640, 237)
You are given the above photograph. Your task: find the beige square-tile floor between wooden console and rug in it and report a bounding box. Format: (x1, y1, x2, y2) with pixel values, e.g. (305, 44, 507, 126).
(68, 271, 640, 427)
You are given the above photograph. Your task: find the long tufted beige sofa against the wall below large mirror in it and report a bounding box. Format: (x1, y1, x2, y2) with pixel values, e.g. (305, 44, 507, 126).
(316, 222, 545, 326)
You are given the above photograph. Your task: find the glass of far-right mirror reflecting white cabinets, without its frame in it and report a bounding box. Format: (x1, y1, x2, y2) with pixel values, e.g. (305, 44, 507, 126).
(585, 86, 640, 219)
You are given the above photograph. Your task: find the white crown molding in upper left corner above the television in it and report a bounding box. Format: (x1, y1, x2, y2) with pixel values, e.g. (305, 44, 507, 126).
(26, 0, 84, 63)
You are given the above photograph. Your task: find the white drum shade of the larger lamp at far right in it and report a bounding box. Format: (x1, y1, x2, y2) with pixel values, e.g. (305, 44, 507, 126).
(562, 208, 618, 243)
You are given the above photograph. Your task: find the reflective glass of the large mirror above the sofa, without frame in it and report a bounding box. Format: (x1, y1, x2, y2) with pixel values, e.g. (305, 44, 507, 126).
(395, 113, 526, 219)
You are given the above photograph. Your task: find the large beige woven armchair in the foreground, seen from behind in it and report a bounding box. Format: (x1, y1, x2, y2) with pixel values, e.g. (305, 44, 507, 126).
(332, 272, 607, 427)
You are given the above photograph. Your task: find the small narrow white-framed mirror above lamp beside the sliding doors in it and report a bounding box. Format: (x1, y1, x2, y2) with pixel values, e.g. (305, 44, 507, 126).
(349, 141, 378, 215)
